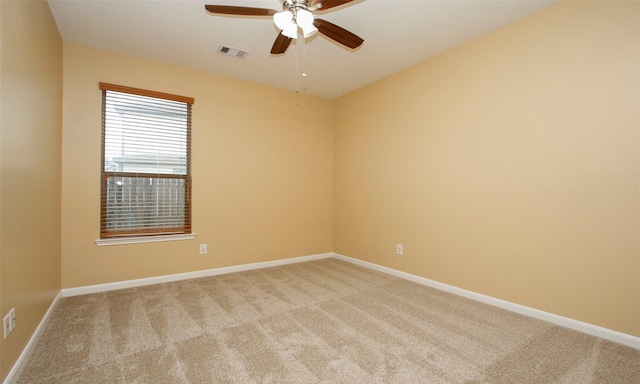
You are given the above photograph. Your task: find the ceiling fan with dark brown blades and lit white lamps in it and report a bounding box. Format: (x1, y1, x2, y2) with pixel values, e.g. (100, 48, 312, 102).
(204, 0, 364, 55)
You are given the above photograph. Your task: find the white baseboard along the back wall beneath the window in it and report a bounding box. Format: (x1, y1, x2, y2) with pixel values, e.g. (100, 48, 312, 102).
(62, 253, 333, 297)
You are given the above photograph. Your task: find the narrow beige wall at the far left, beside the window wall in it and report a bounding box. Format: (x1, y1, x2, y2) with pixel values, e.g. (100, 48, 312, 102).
(0, 1, 62, 380)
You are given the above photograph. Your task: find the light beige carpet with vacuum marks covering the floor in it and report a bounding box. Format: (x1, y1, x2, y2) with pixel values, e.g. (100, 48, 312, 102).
(18, 259, 640, 384)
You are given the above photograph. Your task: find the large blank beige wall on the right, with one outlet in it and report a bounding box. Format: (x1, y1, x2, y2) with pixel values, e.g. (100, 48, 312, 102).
(333, 2, 640, 336)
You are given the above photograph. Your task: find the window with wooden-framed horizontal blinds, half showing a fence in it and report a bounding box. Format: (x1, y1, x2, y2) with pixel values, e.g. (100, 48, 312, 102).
(100, 83, 194, 239)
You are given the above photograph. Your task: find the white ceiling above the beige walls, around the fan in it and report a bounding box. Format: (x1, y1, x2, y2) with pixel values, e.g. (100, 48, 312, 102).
(49, 0, 557, 99)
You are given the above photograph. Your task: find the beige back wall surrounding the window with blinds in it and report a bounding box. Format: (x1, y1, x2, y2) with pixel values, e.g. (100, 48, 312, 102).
(62, 43, 333, 288)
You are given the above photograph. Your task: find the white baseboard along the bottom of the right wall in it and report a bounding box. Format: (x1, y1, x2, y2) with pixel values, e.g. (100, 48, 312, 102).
(333, 253, 640, 349)
